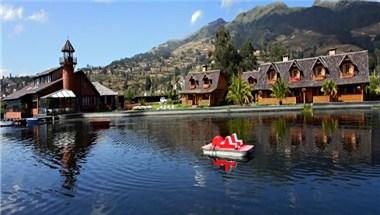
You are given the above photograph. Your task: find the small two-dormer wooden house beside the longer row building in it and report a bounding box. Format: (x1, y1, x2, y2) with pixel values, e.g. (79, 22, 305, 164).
(180, 67, 228, 106)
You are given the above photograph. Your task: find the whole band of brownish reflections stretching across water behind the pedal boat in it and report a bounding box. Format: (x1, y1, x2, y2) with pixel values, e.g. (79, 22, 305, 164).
(131, 112, 371, 164)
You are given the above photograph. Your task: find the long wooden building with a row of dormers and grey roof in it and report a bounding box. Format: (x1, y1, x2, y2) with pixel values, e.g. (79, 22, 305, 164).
(243, 50, 369, 104)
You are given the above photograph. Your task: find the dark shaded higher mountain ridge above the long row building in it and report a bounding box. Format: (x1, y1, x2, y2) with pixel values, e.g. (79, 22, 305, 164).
(226, 1, 380, 55)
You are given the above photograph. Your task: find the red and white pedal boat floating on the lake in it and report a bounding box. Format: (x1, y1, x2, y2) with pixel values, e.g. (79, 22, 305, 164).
(202, 133, 254, 159)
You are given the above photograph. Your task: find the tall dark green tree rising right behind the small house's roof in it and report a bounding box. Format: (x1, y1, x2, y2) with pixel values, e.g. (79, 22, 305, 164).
(213, 26, 240, 78)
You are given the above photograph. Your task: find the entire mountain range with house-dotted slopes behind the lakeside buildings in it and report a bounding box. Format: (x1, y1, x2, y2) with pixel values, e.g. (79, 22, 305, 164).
(7, 0, 380, 95)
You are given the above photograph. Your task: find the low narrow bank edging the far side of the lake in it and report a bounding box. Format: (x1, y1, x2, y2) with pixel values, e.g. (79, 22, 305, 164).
(58, 102, 380, 120)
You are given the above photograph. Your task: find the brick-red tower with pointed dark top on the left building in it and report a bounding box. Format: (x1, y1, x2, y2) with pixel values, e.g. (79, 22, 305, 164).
(59, 40, 77, 90)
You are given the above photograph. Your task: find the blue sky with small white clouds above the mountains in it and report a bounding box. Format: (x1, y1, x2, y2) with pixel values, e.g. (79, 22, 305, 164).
(0, 0, 313, 75)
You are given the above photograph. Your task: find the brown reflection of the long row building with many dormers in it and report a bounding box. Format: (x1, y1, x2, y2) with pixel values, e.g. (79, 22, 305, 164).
(255, 113, 371, 161)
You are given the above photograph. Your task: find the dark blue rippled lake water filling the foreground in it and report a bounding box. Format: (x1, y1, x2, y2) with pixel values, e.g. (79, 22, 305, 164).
(0, 111, 380, 215)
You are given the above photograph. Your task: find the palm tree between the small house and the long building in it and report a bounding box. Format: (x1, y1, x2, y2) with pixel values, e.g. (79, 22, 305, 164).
(226, 75, 253, 105)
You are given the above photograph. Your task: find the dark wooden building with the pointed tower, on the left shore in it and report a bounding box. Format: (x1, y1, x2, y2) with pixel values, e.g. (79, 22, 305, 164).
(4, 40, 121, 119)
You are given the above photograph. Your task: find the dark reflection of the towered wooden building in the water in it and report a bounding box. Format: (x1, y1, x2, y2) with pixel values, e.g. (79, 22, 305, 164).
(33, 123, 96, 189)
